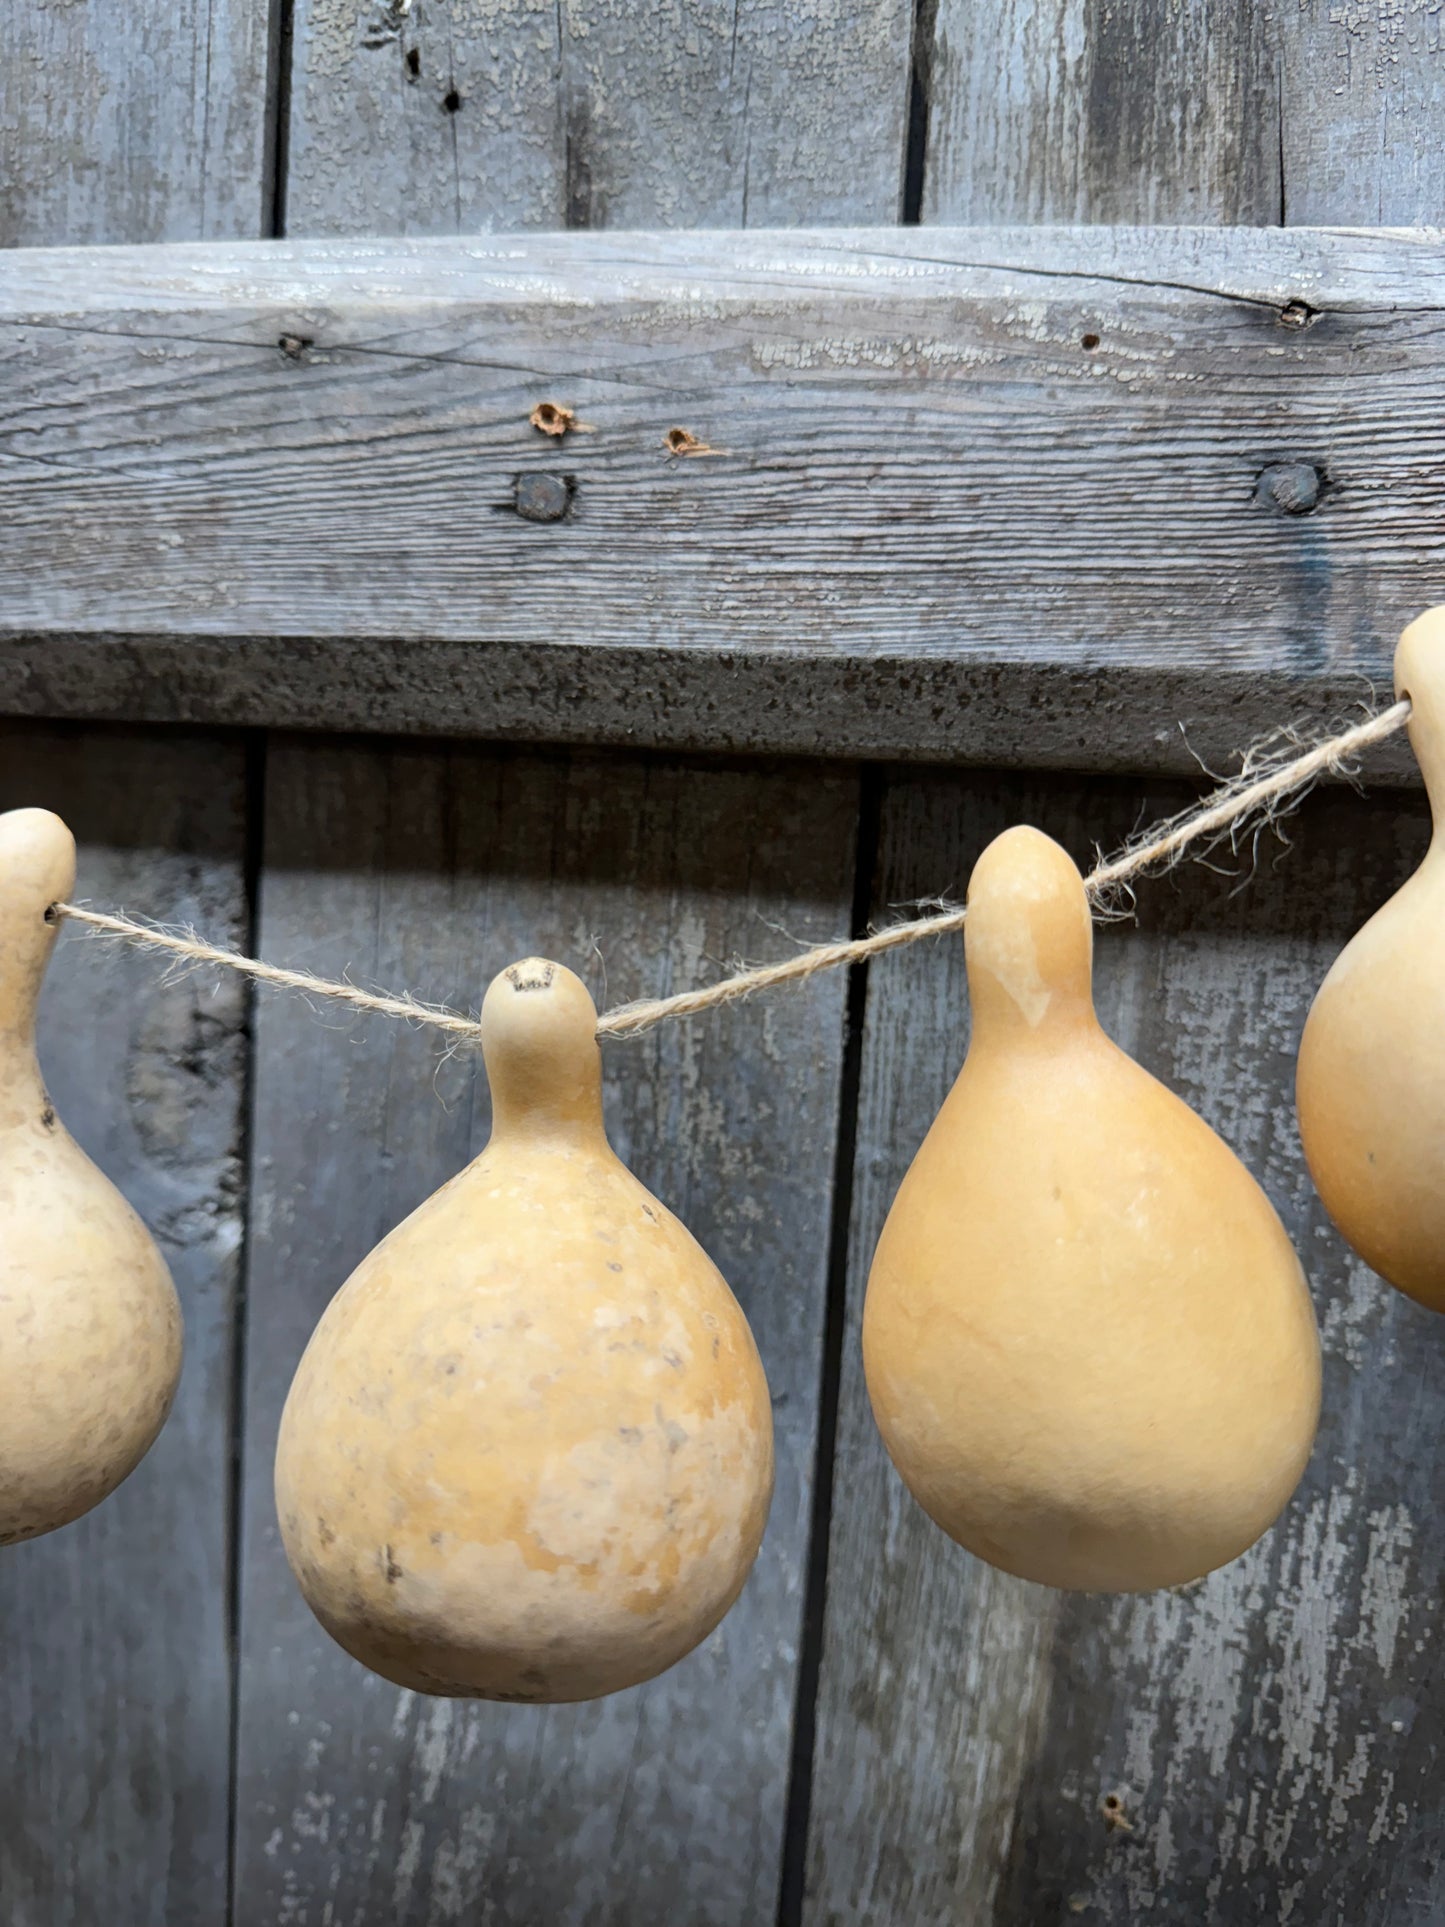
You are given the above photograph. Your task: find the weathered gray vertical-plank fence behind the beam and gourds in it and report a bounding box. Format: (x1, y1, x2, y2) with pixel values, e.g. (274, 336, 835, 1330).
(0, 11, 1445, 1927)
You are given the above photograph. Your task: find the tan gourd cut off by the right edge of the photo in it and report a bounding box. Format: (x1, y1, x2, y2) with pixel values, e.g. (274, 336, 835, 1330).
(1295, 609, 1445, 1312)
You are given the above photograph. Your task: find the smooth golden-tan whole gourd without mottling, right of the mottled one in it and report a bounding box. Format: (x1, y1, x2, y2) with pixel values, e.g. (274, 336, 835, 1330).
(863, 827, 1320, 1592)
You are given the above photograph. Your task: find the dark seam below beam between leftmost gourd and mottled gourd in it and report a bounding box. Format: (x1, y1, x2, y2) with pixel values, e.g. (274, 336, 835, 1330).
(225, 730, 270, 1927)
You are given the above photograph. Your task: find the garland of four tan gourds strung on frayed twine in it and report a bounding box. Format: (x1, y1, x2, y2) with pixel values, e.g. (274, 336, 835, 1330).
(0, 609, 1445, 1702)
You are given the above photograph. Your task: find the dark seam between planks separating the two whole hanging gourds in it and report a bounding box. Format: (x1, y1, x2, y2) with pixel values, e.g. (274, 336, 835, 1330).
(776, 763, 882, 1927)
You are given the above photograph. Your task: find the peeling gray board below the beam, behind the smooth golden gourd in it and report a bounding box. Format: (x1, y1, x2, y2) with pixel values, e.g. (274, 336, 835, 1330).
(803, 777, 1445, 1927)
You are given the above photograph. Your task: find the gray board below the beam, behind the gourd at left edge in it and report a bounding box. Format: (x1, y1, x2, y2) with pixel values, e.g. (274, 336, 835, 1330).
(0, 725, 247, 1927)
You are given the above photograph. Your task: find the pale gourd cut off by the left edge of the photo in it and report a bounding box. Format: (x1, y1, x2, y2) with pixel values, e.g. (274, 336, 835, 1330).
(0, 809, 181, 1545)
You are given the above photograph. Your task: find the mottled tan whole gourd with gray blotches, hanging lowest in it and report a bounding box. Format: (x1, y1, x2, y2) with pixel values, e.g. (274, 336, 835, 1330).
(276, 958, 773, 1702)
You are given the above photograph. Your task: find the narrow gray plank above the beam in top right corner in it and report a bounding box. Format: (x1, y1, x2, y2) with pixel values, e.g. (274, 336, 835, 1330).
(1275, 0, 1445, 227)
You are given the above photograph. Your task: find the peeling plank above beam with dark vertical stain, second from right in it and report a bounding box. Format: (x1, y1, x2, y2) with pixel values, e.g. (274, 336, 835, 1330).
(919, 0, 1287, 224)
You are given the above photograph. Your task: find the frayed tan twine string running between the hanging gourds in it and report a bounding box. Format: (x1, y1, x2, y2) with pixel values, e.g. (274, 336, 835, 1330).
(52, 700, 1410, 1043)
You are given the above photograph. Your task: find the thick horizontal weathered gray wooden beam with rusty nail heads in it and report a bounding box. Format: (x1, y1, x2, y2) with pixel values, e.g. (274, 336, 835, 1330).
(0, 227, 1445, 771)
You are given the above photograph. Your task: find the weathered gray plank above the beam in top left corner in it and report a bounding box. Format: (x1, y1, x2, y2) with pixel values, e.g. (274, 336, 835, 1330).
(0, 0, 272, 247)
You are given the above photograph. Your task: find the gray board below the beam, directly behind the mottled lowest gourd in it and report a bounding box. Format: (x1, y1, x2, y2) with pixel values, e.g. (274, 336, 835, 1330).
(235, 742, 855, 1927)
